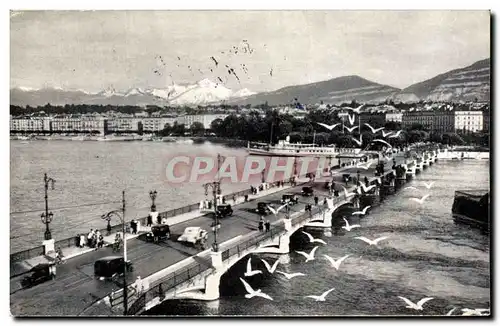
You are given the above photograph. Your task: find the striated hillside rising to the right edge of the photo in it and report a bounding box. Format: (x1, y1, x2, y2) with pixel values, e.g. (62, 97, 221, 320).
(394, 59, 491, 101)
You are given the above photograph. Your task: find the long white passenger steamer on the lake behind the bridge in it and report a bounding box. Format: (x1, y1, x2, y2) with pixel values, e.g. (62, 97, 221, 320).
(247, 136, 348, 158)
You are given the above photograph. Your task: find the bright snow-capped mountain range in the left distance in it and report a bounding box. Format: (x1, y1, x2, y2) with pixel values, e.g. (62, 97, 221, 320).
(10, 79, 254, 106)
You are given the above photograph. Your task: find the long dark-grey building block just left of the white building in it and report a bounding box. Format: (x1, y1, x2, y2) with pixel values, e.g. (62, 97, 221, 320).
(401, 110, 455, 133)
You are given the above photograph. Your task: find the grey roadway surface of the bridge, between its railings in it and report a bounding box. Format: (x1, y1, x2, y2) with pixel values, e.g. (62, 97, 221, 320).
(10, 153, 410, 316)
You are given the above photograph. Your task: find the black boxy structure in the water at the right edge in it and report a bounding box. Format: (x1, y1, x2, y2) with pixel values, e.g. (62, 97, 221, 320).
(451, 190, 490, 233)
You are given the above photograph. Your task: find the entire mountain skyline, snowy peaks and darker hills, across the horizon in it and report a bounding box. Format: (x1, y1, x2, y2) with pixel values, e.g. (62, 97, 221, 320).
(10, 59, 490, 106)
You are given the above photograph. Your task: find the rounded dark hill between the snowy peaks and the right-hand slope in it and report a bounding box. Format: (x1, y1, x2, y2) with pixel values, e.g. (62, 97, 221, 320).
(226, 76, 400, 105)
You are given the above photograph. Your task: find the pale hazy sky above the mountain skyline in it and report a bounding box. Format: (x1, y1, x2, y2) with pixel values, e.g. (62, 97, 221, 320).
(10, 10, 490, 92)
